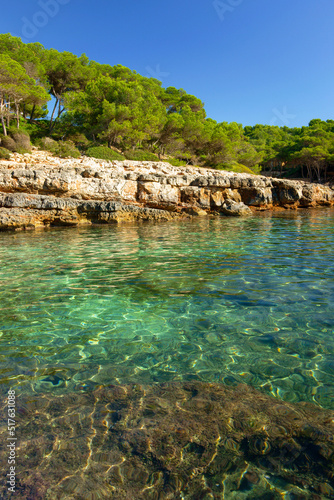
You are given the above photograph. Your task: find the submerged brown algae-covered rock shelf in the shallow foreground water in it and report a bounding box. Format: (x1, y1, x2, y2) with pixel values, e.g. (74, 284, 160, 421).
(0, 381, 334, 500)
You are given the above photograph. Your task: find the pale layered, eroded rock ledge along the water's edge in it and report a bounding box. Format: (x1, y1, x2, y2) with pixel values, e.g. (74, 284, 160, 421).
(0, 151, 334, 230)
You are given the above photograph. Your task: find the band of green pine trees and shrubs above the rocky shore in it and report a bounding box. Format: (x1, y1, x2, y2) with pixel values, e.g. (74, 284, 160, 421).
(0, 34, 334, 182)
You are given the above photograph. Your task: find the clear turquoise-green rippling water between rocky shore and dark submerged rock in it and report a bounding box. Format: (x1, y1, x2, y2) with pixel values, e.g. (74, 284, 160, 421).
(0, 209, 334, 408)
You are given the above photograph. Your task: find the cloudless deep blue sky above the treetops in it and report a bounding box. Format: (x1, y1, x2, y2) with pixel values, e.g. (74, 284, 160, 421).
(0, 0, 334, 127)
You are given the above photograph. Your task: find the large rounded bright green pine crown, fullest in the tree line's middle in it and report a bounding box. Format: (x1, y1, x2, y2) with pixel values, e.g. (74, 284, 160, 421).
(65, 75, 166, 150)
